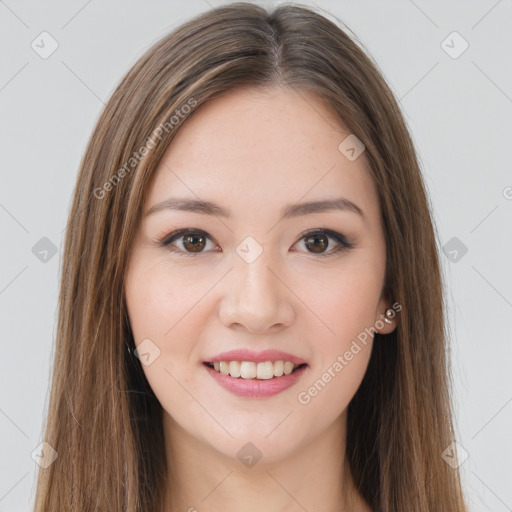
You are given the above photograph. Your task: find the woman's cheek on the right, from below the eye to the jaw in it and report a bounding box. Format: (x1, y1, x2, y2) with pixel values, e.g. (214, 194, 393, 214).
(292, 258, 383, 410)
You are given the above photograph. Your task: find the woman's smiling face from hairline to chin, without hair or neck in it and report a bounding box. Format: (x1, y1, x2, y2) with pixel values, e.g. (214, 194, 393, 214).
(125, 89, 393, 462)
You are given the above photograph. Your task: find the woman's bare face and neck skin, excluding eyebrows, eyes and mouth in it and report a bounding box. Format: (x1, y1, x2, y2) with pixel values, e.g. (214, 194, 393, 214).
(126, 88, 396, 512)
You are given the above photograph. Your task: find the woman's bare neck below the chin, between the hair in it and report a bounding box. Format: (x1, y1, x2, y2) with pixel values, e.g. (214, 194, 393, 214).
(164, 412, 371, 512)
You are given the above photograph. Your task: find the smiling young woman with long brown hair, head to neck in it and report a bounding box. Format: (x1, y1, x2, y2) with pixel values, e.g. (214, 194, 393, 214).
(35, 3, 466, 512)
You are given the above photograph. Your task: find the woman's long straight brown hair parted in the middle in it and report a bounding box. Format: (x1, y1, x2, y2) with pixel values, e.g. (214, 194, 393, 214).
(35, 3, 466, 512)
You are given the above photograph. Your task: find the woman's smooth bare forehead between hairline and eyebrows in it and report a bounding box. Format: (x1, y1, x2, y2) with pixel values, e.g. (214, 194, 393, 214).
(146, 88, 379, 226)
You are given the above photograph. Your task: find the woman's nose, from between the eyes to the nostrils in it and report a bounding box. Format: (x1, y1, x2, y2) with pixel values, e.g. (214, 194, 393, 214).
(219, 246, 295, 333)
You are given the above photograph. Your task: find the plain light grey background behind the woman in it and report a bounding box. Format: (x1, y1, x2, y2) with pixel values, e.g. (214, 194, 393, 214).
(0, 0, 512, 512)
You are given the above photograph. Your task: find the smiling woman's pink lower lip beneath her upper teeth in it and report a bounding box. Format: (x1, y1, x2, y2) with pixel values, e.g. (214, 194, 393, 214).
(203, 364, 307, 398)
